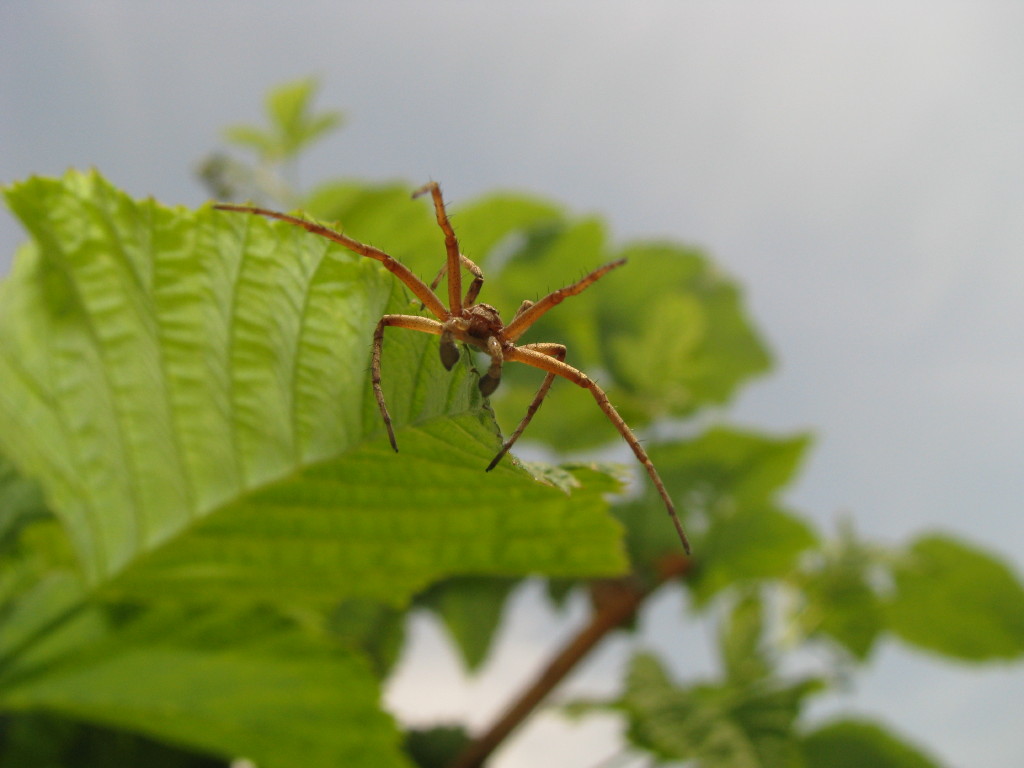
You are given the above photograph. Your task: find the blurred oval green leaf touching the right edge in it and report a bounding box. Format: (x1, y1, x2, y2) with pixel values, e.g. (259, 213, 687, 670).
(886, 535, 1024, 662)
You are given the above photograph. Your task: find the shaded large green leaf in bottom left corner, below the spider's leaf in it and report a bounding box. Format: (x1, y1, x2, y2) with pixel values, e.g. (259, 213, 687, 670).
(0, 468, 404, 768)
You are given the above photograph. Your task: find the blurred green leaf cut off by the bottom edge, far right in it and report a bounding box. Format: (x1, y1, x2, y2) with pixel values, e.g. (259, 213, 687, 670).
(803, 720, 938, 768)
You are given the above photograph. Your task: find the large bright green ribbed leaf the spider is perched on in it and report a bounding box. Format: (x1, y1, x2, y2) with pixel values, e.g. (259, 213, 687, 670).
(0, 172, 624, 603)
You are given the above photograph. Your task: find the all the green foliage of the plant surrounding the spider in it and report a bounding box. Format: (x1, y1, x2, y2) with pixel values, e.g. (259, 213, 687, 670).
(0, 81, 1024, 768)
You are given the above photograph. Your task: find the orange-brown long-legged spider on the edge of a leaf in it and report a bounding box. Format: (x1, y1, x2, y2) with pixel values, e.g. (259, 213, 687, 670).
(214, 181, 690, 554)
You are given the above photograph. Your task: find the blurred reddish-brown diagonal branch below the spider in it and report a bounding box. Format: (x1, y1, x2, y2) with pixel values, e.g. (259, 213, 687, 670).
(452, 555, 692, 768)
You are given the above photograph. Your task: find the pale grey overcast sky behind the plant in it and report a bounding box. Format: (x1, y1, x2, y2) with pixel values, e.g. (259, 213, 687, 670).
(0, 0, 1024, 768)
